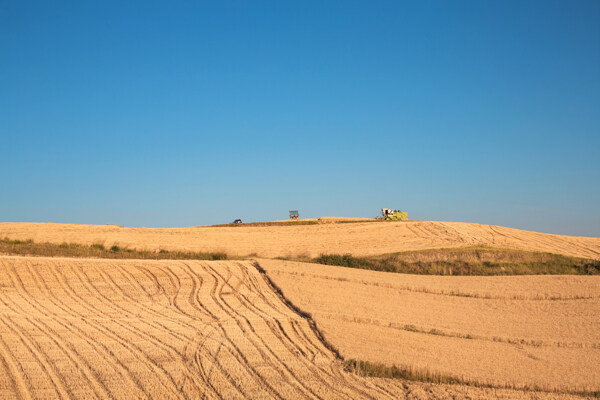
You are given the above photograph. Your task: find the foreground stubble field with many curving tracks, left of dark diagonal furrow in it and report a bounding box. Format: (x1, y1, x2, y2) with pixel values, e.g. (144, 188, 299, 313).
(0, 256, 576, 399)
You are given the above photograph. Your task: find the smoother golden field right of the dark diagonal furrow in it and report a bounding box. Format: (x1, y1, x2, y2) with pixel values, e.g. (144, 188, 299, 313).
(260, 260, 600, 391)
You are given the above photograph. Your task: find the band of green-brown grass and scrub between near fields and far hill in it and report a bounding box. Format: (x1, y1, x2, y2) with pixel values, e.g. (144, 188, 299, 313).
(0, 237, 600, 276)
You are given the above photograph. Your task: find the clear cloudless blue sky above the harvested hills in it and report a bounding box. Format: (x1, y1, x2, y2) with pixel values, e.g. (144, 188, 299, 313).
(0, 0, 600, 236)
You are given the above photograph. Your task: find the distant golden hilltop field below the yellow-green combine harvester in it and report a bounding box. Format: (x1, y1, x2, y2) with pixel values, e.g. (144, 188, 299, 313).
(0, 221, 600, 258)
